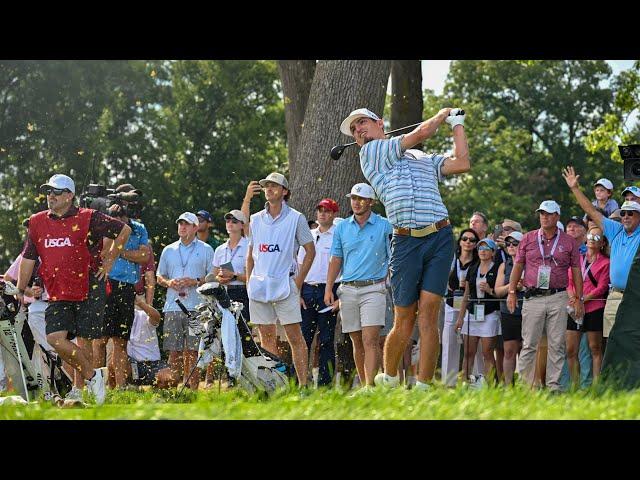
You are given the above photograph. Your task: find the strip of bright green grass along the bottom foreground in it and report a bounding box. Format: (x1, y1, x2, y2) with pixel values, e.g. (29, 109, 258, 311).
(0, 387, 640, 420)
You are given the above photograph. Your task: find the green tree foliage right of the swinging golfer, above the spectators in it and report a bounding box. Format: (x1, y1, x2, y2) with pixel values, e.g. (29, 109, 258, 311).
(424, 60, 622, 229)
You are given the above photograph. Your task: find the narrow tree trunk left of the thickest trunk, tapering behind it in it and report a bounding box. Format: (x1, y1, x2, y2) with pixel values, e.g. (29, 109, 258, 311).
(278, 60, 316, 169)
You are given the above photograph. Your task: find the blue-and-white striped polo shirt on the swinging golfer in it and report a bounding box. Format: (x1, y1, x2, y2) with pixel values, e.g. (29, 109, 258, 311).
(360, 135, 449, 228)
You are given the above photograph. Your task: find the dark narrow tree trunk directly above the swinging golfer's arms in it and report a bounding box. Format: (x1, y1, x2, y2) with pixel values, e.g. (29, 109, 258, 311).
(391, 60, 423, 130)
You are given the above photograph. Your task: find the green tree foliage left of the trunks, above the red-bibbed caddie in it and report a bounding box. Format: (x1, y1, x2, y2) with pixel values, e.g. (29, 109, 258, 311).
(0, 61, 287, 268)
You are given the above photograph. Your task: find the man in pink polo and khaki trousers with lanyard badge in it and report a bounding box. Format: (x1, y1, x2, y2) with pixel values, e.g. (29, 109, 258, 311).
(507, 200, 584, 392)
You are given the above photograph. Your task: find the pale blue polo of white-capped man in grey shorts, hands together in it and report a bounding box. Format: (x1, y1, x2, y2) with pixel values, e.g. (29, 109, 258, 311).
(158, 238, 213, 312)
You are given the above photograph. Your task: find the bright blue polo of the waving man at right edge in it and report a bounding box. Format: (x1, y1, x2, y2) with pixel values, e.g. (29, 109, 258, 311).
(602, 218, 640, 290)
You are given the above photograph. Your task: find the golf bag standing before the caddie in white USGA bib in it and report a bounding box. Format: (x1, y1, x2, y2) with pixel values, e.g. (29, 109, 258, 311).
(182, 282, 291, 393)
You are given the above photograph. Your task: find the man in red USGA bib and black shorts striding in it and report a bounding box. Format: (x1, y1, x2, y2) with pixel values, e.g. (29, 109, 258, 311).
(18, 174, 131, 404)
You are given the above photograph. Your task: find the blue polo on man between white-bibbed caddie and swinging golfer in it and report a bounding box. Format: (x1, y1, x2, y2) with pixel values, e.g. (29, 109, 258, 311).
(331, 212, 393, 282)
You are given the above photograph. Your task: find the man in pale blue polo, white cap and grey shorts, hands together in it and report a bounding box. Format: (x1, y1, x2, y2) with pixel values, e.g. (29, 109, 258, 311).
(156, 212, 213, 390)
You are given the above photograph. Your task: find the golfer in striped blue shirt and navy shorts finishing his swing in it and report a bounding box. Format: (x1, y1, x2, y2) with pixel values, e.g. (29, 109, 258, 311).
(340, 108, 471, 389)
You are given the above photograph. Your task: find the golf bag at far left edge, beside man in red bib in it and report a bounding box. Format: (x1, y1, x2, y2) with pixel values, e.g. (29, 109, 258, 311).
(0, 281, 73, 402)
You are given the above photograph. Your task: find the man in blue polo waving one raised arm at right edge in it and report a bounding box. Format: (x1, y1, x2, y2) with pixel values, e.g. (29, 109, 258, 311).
(562, 167, 640, 338)
